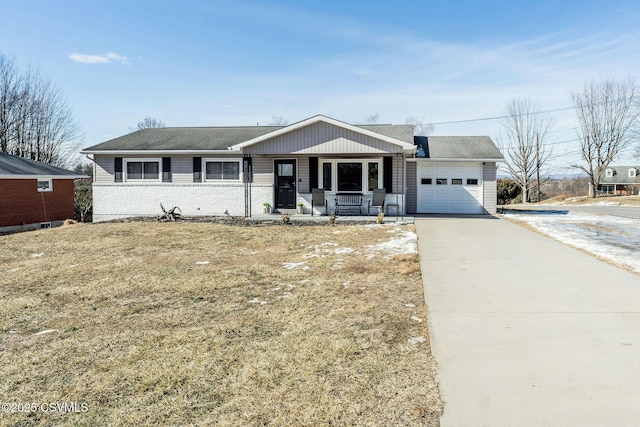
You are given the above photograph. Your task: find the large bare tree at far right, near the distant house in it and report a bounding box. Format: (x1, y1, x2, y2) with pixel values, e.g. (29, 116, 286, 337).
(571, 79, 640, 197)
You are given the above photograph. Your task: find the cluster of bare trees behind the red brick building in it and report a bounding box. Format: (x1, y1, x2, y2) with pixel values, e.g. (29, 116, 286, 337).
(0, 54, 81, 166)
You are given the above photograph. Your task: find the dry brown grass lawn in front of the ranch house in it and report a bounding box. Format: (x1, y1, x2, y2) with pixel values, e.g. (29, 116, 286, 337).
(0, 223, 442, 426)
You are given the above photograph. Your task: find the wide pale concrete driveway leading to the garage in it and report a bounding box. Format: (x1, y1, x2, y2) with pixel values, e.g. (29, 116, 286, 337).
(416, 217, 640, 427)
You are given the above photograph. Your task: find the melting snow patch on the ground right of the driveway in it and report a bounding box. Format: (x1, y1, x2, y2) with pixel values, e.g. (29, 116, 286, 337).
(505, 212, 640, 272)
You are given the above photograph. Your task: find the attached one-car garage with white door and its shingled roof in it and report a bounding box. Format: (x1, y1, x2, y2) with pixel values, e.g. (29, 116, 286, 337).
(407, 136, 504, 215)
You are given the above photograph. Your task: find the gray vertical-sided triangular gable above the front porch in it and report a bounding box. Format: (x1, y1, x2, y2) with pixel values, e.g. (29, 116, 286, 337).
(244, 123, 402, 155)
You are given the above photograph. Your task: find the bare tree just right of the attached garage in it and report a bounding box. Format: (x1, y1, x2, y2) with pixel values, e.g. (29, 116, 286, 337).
(498, 98, 554, 203)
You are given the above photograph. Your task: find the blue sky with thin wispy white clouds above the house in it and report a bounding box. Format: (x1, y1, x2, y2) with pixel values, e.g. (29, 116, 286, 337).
(0, 0, 640, 172)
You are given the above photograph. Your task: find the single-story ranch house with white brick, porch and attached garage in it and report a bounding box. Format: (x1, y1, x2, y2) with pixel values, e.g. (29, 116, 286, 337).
(82, 115, 504, 222)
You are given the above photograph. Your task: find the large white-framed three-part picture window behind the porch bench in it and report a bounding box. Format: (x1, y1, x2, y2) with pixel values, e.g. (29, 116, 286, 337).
(318, 158, 383, 193)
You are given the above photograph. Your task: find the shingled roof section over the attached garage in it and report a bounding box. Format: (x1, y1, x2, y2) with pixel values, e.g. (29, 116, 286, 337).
(415, 136, 504, 161)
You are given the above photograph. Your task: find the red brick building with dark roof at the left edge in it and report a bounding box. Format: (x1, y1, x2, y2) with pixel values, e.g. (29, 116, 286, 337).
(0, 153, 86, 227)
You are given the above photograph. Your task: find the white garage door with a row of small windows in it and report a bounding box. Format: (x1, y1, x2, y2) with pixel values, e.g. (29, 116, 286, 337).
(416, 162, 483, 214)
